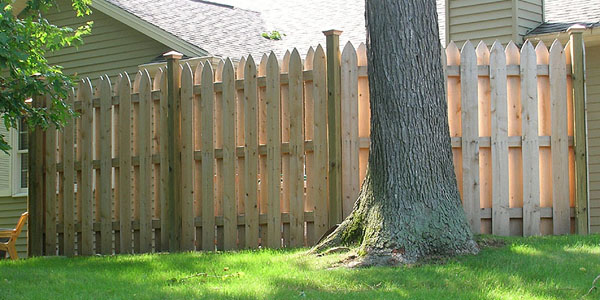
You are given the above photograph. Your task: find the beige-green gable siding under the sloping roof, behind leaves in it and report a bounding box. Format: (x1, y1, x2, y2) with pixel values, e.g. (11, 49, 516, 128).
(46, 1, 170, 79)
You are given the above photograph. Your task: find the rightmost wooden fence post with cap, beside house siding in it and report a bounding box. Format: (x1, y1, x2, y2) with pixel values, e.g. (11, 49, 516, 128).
(568, 25, 588, 234)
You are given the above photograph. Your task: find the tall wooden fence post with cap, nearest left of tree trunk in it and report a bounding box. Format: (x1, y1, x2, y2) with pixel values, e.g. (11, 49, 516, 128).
(323, 29, 342, 227)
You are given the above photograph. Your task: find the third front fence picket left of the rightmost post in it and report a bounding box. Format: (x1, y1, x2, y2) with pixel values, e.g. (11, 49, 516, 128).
(490, 42, 510, 236)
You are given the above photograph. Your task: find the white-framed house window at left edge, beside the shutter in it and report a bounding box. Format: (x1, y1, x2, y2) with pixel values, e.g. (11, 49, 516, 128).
(13, 119, 29, 194)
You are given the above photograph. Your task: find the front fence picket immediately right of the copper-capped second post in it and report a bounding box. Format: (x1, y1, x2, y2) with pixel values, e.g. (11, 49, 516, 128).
(181, 63, 196, 251)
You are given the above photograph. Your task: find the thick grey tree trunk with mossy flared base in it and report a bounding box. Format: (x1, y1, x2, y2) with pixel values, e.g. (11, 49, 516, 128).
(313, 0, 478, 265)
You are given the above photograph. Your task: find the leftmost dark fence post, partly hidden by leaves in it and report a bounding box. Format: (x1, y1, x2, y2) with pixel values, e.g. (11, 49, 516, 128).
(27, 92, 46, 257)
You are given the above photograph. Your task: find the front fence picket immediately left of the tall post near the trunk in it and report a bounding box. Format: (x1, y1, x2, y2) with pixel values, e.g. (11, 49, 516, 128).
(311, 45, 329, 241)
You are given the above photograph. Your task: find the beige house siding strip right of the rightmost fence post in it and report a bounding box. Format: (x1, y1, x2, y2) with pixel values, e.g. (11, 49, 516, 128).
(586, 45, 600, 233)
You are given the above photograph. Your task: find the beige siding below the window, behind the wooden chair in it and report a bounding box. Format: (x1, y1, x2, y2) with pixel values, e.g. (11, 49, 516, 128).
(0, 197, 27, 257)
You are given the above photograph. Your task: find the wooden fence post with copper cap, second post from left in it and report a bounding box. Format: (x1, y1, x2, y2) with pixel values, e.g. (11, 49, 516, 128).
(161, 51, 183, 252)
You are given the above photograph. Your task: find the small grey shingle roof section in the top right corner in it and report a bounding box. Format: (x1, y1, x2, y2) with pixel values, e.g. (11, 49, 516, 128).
(528, 0, 600, 35)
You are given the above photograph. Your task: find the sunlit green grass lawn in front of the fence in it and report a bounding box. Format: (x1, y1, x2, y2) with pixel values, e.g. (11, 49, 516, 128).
(0, 235, 600, 300)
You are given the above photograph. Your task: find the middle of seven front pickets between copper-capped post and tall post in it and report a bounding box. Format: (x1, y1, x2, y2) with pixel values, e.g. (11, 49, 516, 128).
(244, 55, 259, 248)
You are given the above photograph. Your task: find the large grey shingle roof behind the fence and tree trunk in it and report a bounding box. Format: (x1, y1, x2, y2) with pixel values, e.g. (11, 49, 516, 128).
(103, 0, 444, 59)
